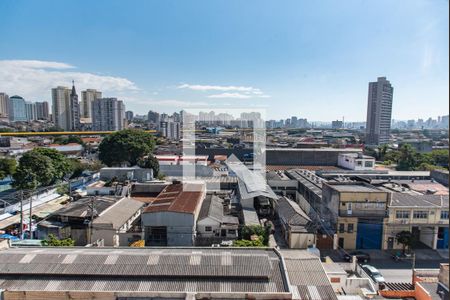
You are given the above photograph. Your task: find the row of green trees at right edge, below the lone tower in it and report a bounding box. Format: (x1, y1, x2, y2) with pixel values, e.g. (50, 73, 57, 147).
(366, 144, 449, 171)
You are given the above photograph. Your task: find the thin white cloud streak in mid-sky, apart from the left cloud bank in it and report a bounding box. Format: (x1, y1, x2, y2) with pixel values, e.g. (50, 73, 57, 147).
(177, 83, 270, 99)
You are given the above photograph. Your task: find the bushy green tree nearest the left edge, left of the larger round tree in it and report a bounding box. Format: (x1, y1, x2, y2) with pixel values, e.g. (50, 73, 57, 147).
(13, 151, 56, 189)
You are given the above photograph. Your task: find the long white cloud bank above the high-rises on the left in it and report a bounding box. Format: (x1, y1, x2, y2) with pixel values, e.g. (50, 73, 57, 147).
(0, 60, 138, 101)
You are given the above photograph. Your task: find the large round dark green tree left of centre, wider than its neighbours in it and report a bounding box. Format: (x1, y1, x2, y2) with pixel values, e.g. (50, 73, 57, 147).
(98, 129, 155, 167)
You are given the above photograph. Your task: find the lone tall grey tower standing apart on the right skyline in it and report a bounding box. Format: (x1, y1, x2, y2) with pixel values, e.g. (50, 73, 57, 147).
(366, 77, 394, 145)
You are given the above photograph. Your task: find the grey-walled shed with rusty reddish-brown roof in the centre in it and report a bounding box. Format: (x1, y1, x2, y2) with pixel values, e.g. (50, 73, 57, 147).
(142, 183, 206, 246)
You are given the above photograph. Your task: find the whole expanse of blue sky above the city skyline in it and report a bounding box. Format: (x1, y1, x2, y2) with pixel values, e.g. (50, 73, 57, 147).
(0, 0, 449, 121)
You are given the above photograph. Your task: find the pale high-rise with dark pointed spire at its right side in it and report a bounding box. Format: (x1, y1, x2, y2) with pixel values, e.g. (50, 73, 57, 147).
(52, 82, 80, 131)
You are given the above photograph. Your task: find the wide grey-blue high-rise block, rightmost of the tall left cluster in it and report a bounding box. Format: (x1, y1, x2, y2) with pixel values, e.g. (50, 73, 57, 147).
(92, 98, 125, 131)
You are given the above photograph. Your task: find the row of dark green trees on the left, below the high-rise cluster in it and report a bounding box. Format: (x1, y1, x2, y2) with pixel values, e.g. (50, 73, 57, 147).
(0, 129, 159, 189)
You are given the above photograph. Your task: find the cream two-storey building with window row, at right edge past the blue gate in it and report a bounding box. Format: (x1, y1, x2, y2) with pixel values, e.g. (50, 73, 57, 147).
(383, 193, 449, 249)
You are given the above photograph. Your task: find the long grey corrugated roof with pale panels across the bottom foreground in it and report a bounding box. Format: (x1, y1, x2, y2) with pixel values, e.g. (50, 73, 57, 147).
(0, 248, 288, 293)
